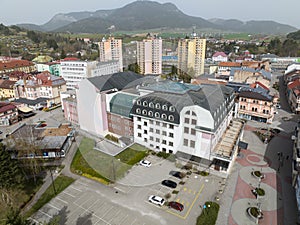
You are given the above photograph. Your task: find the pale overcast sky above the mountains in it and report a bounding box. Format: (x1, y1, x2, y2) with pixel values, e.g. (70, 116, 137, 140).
(0, 0, 300, 28)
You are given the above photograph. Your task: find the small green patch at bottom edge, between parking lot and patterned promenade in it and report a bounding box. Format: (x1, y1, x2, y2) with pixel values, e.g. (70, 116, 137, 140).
(197, 202, 220, 225)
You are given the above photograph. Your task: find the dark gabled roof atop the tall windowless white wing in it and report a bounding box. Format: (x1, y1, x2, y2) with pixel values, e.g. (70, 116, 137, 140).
(87, 71, 144, 92)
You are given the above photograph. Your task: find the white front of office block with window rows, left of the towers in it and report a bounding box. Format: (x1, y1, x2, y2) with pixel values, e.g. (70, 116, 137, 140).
(61, 60, 97, 89)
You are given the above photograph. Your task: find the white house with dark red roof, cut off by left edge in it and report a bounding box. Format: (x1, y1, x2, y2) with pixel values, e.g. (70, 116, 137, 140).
(0, 102, 18, 126)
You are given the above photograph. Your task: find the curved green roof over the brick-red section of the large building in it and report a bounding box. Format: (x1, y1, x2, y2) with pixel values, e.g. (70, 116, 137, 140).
(109, 93, 138, 118)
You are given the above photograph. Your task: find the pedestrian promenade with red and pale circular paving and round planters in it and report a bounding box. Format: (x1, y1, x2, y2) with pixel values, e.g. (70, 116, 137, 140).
(216, 124, 296, 225)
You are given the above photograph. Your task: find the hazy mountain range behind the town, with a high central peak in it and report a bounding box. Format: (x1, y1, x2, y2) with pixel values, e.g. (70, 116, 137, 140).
(18, 1, 297, 34)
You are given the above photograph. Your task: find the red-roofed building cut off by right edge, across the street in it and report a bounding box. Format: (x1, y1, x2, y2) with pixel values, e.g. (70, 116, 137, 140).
(286, 79, 300, 114)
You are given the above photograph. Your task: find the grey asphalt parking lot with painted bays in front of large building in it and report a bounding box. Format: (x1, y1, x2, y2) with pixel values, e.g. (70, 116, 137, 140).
(33, 155, 222, 225)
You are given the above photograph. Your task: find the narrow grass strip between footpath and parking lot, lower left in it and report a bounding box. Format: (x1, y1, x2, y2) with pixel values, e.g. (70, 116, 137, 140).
(26, 175, 74, 217)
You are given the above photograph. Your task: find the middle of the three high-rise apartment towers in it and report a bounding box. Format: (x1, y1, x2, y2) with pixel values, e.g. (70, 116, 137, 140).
(137, 37, 162, 75)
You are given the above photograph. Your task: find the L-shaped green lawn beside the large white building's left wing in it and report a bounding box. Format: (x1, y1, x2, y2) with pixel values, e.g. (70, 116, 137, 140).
(71, 138, 147, 184)
